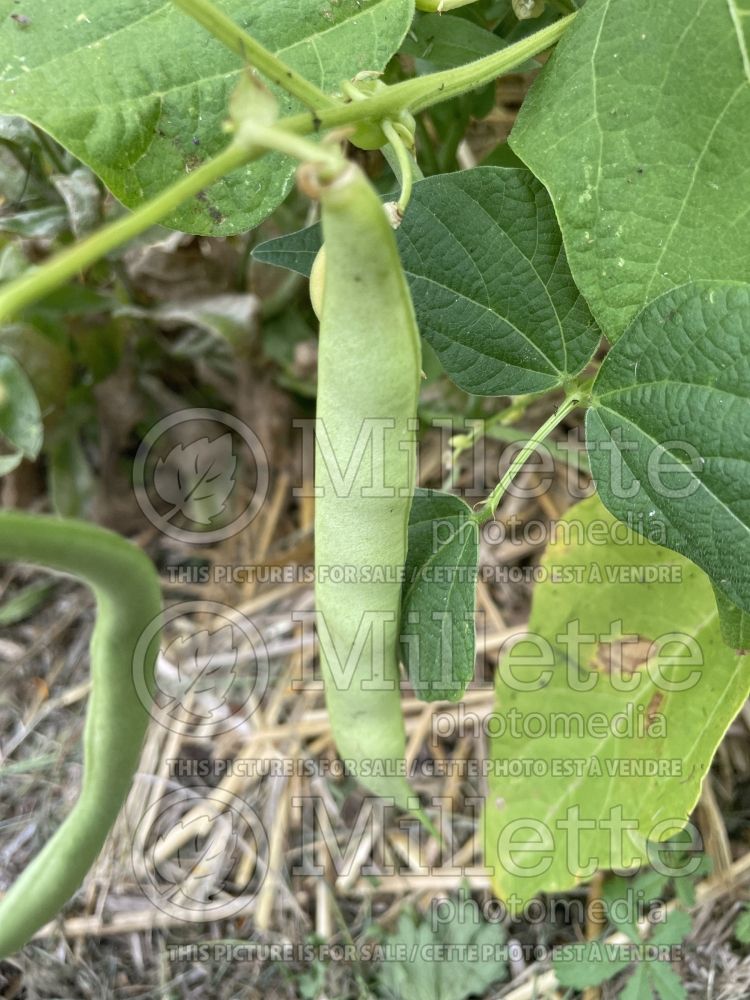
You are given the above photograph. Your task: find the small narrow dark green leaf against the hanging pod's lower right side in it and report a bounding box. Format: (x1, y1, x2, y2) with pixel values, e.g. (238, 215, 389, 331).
(401, 490, 479, 701)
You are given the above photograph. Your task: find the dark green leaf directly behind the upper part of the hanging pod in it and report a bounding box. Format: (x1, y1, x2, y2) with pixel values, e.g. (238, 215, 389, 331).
(255, 167, 600, 396)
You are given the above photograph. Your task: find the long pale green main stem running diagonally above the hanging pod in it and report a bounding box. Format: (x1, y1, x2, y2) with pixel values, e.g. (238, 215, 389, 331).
(0, 14, 576, 323)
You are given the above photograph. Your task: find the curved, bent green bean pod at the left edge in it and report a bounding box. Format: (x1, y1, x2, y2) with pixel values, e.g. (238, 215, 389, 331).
(0, 511, 161, 958)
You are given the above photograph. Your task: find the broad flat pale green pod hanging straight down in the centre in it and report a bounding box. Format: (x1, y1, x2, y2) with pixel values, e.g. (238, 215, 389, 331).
(306, 164, 421, 809)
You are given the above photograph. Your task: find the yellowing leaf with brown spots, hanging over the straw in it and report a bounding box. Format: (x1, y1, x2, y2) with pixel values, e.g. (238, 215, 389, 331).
(485, 497, 750, 900)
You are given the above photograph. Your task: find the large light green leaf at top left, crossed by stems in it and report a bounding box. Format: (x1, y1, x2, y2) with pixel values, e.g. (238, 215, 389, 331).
(0, 0, 414, 235)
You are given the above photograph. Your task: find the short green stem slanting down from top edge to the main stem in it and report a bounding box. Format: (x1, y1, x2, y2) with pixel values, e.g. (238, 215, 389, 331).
(173, 0, 337, 110)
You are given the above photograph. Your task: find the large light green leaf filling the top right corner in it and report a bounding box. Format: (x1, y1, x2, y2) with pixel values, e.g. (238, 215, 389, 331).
(510, 0, 750, 340)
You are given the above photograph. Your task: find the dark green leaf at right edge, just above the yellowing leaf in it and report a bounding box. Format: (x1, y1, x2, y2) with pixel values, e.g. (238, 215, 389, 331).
(586, 282, 750, 611)
